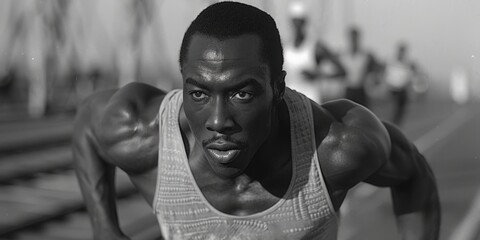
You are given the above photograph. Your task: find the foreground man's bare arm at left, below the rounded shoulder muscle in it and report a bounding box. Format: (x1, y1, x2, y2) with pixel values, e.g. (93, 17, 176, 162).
(72, 92, 129, 240)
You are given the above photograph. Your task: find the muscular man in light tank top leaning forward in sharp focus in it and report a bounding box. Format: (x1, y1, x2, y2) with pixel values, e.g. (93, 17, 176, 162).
(73, 2, 439, 239)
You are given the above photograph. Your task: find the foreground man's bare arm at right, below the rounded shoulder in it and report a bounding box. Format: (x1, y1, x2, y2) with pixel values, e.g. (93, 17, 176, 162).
(372, 123, 441, 239)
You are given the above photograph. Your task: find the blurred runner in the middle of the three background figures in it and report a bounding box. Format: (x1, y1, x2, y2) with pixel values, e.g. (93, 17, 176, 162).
(340, 27, 377, 107)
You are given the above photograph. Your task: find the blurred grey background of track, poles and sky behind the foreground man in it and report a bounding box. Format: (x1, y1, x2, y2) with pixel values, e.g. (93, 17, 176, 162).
(0, 0, 480, 240)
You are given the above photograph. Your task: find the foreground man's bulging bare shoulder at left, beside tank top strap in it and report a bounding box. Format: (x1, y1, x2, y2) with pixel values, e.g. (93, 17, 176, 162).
(72, 83, 169, 173)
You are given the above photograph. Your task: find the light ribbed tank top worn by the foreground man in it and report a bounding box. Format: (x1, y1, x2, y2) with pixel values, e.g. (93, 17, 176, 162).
(153, 88, 338, 240)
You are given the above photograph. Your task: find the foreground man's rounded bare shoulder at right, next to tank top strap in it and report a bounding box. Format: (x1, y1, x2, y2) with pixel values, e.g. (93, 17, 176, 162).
(317, 99, 390, 195)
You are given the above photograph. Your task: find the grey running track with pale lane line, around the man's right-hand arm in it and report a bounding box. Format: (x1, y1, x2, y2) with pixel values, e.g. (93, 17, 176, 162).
(339, 97, 480, 240)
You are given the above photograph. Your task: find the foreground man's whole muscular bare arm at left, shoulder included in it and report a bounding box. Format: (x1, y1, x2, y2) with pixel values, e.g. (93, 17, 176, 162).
(73, 83, 165, 240)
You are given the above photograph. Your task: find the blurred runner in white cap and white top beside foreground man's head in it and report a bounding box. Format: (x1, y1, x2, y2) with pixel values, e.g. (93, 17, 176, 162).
(284, 1, 344, 103)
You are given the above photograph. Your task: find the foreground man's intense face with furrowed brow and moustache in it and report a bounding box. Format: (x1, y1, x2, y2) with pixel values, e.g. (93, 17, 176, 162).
(182, 34, 273, 177)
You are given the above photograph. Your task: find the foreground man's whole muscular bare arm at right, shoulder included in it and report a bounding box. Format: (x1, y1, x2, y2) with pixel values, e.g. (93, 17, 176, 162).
(323, 100, 440, 239)
